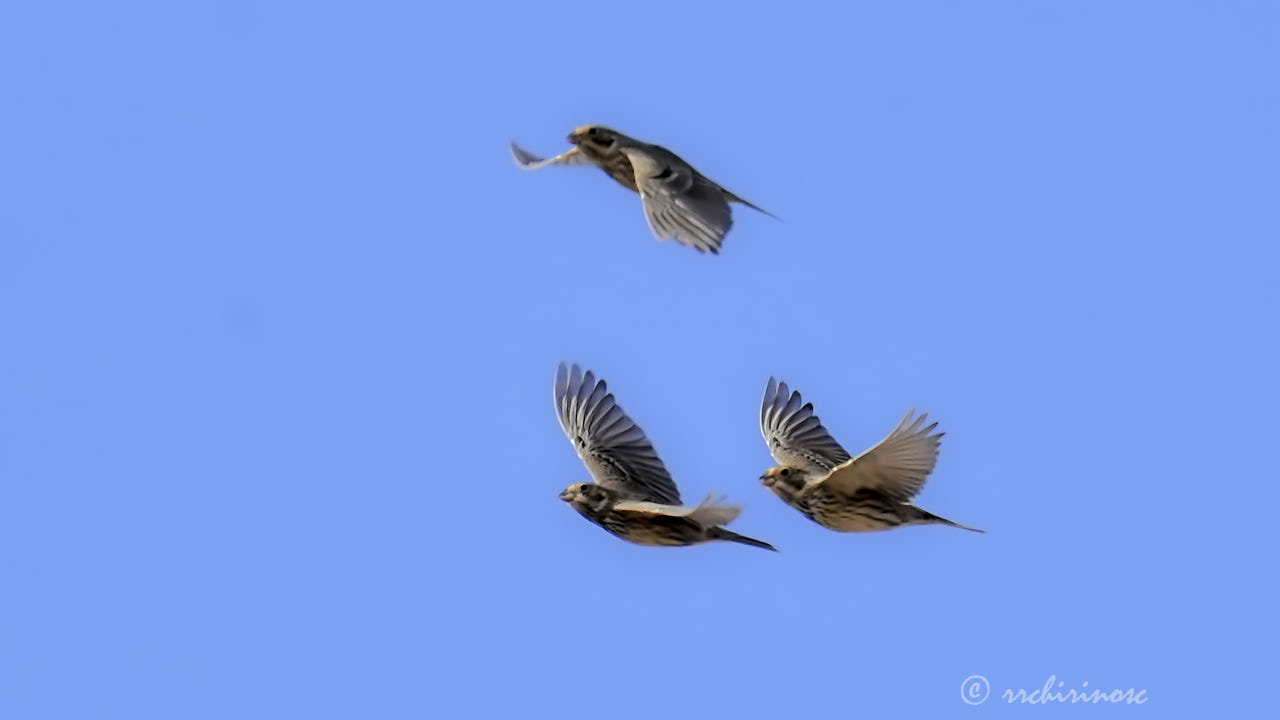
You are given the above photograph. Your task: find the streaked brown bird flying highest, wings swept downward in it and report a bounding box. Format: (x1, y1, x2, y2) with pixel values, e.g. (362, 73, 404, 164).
(511, 126, 773, 254)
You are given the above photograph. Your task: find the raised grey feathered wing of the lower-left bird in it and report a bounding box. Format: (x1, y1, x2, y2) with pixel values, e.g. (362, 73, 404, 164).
(554, 363, 680, 505)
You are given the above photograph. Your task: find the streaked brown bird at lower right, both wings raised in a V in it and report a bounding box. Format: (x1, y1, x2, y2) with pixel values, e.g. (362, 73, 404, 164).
(760, 378, 983, 533)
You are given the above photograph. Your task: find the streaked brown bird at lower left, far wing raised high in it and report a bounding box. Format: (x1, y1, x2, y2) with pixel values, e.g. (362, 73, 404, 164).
(554, 364, 774, 550)
